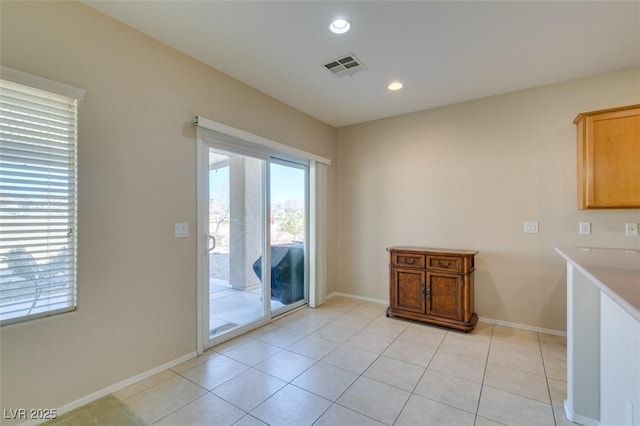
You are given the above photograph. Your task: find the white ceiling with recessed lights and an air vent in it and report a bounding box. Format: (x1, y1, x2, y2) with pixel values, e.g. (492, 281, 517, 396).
(84, 0, 640, 127)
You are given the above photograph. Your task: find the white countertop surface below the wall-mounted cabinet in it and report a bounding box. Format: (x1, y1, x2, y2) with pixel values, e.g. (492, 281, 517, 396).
(556, 247, 640, 321)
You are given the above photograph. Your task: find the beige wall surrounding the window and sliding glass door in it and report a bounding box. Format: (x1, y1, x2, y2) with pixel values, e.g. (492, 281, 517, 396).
(0, 1, 336, 416)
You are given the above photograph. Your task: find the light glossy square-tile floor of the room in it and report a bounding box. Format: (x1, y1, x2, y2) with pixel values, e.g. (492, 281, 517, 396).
(116, 297, 573, 426)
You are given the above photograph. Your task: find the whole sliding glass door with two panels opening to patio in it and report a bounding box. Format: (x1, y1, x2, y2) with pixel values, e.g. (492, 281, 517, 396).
(199, 143, 309, 348)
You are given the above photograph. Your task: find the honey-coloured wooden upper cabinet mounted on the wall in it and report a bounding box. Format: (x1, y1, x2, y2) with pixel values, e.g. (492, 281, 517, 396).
(573, 105, 640, 209)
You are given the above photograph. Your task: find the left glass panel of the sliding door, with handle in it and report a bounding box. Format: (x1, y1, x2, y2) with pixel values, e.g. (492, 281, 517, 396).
(207, 148, 266, 339)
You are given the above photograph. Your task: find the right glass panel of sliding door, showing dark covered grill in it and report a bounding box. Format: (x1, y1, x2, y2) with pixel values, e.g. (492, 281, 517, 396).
(269, 159, 308, 313)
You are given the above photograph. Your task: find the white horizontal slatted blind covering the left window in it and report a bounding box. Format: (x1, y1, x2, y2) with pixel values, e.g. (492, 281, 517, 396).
(0, 80, 77, 325)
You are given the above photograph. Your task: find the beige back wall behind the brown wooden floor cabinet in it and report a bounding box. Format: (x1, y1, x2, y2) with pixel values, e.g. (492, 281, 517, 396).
(337, 68, 640, 330)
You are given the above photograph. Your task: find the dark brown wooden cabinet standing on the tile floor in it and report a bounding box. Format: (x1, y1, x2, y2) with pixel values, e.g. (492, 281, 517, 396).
(387, 247, 478, 332)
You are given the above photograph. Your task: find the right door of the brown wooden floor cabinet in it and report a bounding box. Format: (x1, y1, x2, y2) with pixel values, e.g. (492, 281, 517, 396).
(427, 272, 464, 320)
